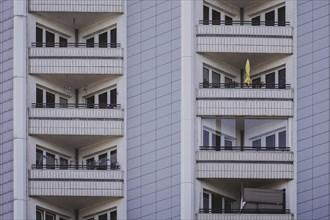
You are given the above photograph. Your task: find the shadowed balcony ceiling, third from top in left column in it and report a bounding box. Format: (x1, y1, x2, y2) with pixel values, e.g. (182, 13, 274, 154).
(38, 135, 117, 149)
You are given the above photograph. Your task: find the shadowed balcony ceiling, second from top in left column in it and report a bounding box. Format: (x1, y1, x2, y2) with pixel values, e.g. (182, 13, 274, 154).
(39, 74, 117, 92)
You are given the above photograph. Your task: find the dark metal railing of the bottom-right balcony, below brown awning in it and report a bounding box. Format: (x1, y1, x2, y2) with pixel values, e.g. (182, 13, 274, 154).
(199, 208, 290, 214)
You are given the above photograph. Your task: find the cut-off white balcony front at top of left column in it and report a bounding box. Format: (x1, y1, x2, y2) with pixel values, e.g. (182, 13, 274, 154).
(29, 0, 124, 13)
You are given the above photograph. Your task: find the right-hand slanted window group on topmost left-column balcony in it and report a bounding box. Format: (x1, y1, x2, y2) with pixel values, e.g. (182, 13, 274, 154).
(86, 28, 117, 48)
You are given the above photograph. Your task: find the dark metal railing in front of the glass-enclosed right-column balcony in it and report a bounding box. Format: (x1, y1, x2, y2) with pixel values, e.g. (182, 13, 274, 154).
(199, 146, 290, 152)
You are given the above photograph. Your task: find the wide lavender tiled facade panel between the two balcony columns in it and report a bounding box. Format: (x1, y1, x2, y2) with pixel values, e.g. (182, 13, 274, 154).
(127, 0, 181, 219)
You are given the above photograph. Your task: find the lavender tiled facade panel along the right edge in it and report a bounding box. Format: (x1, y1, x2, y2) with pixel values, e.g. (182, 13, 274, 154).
(297, 0, 330, 220)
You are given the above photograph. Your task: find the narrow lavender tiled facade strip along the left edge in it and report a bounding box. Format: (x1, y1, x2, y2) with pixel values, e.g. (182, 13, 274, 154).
(0, 0, 13, 219)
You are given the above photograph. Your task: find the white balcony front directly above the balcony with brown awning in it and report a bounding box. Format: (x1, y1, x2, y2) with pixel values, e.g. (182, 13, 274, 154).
(196, 147, 294, 180)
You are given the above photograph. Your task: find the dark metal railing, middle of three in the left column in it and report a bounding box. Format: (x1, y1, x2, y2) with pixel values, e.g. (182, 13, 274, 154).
(32, 103, 121, 109)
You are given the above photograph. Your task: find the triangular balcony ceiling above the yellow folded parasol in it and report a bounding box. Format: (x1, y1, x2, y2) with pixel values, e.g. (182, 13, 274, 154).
(204, 53, 287, 69)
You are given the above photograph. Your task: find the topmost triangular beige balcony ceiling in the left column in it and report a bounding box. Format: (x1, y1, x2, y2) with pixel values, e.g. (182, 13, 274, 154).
(39, 12, 114, 29)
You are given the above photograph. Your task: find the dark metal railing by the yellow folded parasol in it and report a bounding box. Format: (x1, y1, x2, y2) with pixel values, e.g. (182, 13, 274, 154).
(199, 82, 291, 89)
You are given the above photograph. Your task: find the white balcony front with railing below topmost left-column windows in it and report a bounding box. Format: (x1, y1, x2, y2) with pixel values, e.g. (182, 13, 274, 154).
(29, 43, 124, 75)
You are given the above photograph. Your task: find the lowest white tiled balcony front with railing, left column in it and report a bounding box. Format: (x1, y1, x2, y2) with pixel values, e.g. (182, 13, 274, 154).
(28, 165, 124, 197)
